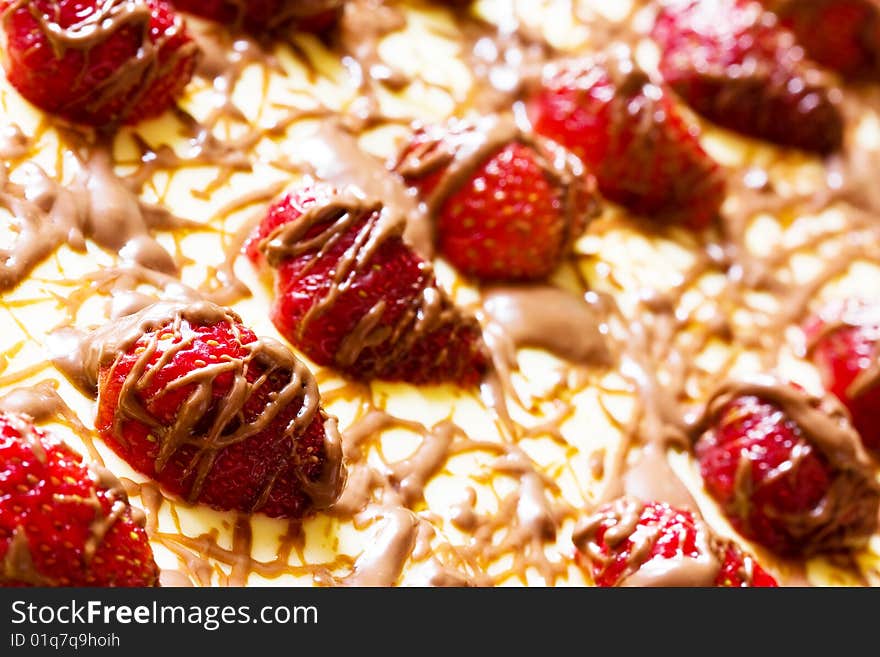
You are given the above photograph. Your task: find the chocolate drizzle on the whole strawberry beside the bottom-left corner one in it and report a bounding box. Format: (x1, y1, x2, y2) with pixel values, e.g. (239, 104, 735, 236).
(49, 301, 344, 510)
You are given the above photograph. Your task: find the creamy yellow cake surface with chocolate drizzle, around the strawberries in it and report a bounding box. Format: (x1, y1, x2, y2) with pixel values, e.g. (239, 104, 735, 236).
(0, 0, 880, 586)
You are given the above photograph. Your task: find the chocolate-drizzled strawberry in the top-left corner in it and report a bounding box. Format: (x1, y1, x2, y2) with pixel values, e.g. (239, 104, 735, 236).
(0, 0, 198, 126)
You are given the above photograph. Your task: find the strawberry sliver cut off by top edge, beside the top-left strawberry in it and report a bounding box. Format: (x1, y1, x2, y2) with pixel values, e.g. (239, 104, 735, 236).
(173, 0, 345, 33)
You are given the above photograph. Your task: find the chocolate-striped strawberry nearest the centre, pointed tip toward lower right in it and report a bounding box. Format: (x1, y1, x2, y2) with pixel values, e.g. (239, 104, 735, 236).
(246, 184, 488, 386)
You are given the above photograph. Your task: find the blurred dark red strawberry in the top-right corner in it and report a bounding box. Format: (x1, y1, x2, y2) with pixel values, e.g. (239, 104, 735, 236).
(764, 0, 880, 79)
